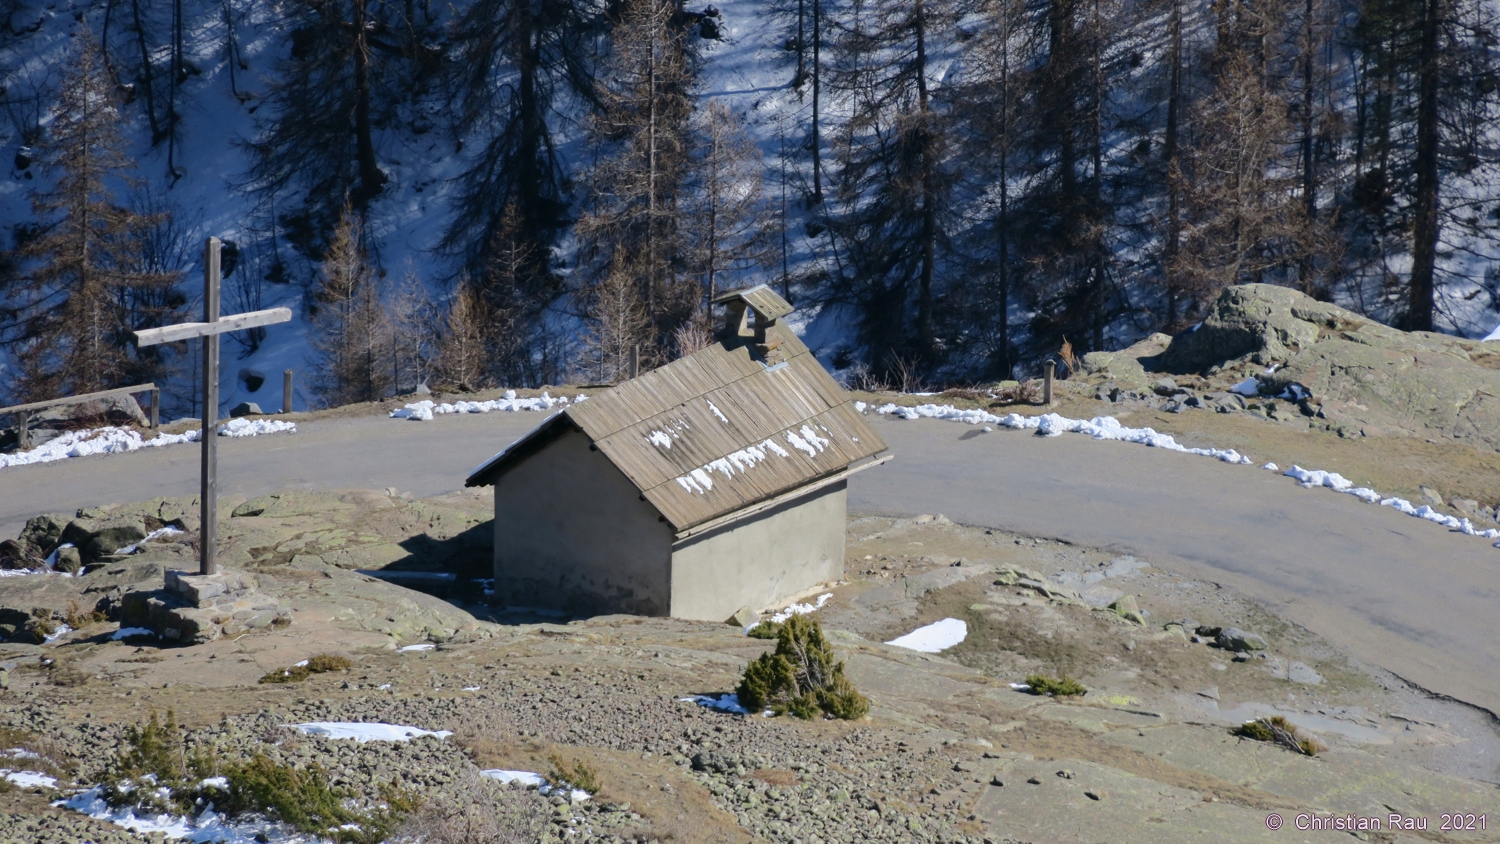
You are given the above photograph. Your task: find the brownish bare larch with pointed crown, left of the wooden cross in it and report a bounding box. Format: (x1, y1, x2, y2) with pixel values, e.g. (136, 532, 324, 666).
(3, 33, 182, 400)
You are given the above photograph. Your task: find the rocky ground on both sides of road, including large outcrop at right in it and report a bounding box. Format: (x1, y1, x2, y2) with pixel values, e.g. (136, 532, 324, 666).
(0, 285, 1500, 844)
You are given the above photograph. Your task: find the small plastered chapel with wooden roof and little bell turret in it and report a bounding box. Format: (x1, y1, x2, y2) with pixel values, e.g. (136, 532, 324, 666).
(467, 285, 891, 621)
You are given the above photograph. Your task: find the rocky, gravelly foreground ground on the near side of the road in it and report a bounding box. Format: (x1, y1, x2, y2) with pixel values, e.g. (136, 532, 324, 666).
(0, 492, 1500, 843)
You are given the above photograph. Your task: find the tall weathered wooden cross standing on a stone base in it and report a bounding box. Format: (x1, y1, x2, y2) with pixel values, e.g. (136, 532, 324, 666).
(134, 237, 291, 574)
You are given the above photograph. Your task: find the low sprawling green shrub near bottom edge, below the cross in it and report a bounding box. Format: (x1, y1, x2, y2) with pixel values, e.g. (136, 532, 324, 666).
(224, 754, 417, 844)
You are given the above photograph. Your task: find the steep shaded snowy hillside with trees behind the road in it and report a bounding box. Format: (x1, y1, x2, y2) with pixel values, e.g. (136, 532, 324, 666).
(0, 0, 1500, 415)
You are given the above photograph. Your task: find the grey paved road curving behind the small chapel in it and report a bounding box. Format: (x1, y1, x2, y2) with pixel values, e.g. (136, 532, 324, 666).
(0, 414, 1500, 712)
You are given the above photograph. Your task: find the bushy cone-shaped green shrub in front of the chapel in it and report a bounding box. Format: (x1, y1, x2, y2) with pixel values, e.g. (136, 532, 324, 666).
(737, 615, 870, 721)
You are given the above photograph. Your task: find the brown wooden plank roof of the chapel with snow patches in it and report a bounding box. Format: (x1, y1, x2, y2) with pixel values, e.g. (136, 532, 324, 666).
(468, 299, 887, 531)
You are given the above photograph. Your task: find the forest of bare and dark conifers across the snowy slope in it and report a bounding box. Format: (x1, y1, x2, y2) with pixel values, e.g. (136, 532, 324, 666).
(0, 0, 1500, 402)
